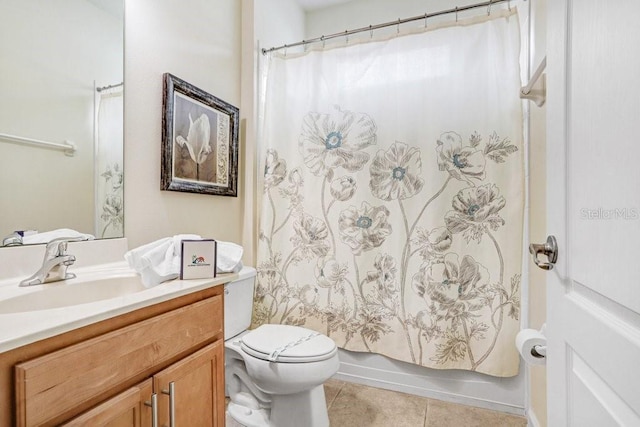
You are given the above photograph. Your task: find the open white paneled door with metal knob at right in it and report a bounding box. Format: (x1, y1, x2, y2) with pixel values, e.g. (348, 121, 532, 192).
(540, 0, 640, 427)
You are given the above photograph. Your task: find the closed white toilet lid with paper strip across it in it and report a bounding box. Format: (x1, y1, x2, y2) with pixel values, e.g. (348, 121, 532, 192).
(241, 325, 337, 363)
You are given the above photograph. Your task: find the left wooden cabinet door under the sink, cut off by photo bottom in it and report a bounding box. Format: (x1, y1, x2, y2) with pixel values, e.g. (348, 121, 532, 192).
(62, 379, 152, 427)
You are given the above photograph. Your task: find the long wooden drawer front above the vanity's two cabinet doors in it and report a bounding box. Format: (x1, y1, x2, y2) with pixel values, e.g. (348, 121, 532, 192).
(15, 295, 223, 426)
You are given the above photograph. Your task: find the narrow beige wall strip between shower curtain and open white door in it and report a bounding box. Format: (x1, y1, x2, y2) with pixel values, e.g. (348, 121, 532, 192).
(529, 0, 547, 426)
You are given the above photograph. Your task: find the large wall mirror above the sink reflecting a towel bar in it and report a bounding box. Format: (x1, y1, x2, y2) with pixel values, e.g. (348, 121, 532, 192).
(0, 0, 124, 245)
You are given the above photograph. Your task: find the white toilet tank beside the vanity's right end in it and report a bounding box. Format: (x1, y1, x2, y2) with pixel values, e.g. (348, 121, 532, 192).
(224, 267, 256, 340)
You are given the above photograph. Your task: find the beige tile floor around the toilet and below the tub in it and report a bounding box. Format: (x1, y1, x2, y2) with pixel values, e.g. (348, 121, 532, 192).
(227, 379, 527, 427)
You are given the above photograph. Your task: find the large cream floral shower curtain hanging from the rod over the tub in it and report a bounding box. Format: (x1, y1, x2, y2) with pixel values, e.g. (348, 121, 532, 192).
(254, 11, 524, 377)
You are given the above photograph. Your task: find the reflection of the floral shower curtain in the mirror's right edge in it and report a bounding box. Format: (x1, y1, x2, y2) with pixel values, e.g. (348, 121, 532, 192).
(95, 86, 124, 238)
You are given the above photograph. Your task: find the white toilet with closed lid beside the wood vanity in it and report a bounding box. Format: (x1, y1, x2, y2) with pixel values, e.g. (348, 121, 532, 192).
(224, 267, 339, 427)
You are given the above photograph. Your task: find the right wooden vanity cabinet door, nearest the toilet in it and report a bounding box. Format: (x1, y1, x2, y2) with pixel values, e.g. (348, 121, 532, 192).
(153, 340, 225, 427)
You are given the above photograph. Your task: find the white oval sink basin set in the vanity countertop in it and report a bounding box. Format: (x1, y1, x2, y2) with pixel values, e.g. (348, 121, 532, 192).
(0, 275, 146, 314)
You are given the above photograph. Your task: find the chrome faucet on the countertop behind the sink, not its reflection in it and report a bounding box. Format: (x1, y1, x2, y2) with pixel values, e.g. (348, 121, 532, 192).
(20, 237, 82, 286)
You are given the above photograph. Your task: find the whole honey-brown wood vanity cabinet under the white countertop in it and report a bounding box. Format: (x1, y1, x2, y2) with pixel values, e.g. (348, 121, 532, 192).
(0, 286, 225, 427)
